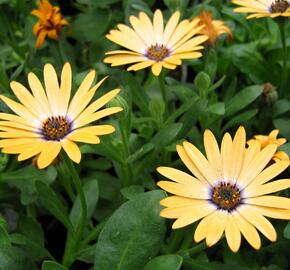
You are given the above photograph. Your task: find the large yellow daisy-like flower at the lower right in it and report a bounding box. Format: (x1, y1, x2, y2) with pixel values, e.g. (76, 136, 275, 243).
(157, 127, 290, 252)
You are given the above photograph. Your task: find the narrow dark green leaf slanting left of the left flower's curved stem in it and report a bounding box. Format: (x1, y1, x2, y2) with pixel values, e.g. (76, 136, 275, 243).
(36, 181, 74, 232)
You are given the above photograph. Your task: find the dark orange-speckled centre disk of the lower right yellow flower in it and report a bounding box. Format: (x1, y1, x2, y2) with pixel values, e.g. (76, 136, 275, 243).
(212, 182, 241, 211)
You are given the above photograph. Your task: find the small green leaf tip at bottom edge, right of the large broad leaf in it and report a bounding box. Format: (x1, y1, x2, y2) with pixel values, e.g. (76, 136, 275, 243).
(143, 255, 183, 270)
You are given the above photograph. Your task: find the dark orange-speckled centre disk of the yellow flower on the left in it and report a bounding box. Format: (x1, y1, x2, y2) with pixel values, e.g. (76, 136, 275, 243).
(42, 116, 71, 141)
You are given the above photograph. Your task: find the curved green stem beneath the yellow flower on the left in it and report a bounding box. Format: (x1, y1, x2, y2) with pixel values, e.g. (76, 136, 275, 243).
(61, 153, 87, 267)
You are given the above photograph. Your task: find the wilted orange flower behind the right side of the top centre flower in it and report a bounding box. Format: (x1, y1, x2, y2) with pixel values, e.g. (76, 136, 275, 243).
(197, 11, 233, 46)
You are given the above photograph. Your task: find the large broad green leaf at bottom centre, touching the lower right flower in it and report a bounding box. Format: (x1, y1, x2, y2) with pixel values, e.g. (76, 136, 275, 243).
(94, 190, 166, 270)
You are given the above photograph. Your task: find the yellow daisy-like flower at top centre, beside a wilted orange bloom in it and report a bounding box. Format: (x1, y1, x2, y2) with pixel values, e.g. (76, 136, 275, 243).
(104, 10, 207, 76)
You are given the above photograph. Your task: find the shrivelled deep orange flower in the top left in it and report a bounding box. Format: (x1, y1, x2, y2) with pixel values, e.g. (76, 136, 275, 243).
(31, 0, 68, 48)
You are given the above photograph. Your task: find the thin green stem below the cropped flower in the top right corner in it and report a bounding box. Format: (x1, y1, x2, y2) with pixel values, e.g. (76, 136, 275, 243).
(278, 20, 288, 96)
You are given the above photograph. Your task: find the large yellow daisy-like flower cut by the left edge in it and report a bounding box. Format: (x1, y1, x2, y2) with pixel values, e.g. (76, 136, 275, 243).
(0, 63, 122, 168)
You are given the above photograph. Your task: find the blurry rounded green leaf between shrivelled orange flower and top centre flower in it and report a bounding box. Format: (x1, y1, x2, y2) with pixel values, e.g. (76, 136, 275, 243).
(71, 9, 111, 42)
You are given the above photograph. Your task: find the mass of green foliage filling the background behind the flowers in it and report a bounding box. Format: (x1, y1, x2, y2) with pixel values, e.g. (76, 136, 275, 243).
(0, 0, 290, 270)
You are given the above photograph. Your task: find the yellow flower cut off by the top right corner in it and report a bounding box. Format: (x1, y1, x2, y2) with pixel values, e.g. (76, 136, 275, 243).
(233, 0, 290, 19)
